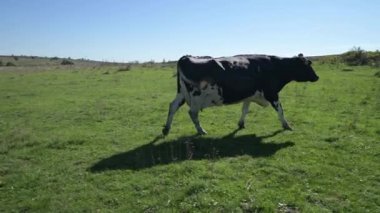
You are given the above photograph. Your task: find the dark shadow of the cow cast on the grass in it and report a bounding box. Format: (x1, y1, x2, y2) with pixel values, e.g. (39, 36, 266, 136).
(89, 130, 294, 172)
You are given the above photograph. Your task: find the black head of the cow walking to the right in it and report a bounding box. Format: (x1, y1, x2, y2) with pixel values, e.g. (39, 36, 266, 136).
(292, 53, 319, 82)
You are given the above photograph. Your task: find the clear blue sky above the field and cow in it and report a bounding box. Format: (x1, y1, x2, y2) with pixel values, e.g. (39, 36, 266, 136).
(0, 0, 380, 62)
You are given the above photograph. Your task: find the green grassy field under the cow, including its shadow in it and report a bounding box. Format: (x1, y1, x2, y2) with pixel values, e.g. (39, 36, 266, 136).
(0, 59, 380, 212)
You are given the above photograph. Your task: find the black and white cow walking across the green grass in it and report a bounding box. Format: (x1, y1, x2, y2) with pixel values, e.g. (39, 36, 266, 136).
(162, 54, 319, 135)
